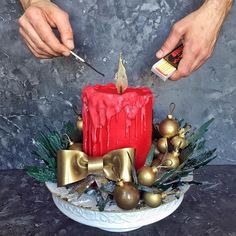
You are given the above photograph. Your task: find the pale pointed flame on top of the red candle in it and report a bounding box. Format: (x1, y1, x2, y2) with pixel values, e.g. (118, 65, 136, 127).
(115, 53, 128, 94)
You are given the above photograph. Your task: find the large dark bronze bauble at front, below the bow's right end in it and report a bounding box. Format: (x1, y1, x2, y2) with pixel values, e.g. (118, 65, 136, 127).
(114, 181, 140, 210)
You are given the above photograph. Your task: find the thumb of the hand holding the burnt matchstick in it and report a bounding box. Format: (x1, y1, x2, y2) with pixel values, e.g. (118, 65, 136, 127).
(54, 12, 74, 50)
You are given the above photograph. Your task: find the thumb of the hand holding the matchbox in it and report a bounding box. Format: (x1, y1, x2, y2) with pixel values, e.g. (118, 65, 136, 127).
(156, 23, 185, 58)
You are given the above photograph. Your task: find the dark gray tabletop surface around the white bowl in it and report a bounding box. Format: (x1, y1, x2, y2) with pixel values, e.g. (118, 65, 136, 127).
(0, 166, 236, 236)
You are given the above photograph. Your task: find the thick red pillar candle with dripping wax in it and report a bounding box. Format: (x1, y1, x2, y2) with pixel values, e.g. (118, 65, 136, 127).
(82, 84, 153, 169)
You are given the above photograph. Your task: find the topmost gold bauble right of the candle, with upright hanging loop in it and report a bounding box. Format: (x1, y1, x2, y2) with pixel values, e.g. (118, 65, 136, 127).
(158, 103, 179, 138)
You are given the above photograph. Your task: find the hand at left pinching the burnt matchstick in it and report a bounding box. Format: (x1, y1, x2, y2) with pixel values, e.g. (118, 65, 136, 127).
(19, 0, 74, 58)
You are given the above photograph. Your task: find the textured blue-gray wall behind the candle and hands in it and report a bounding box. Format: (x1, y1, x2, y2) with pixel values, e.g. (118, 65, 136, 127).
(0, 0, 236, 169)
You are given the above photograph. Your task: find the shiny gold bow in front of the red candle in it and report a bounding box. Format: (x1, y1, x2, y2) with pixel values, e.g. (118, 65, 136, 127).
(57, 148, 135, 187)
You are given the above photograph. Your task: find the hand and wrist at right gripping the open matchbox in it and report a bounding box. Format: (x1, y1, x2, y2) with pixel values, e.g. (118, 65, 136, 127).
(156, 0, 233, 80)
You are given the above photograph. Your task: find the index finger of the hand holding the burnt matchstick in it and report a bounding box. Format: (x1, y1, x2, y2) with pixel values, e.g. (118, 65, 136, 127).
(26, 11, 70, 56)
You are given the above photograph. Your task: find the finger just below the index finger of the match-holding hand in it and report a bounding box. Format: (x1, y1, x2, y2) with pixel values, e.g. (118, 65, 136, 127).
(19, 17, 60, 56)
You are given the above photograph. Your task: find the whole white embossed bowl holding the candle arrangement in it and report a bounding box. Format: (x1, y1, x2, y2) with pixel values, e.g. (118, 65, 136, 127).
(46, 175, 192, 232)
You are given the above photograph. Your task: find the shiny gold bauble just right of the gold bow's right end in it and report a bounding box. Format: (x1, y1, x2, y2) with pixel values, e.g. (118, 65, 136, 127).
(138, 166, 157, 186)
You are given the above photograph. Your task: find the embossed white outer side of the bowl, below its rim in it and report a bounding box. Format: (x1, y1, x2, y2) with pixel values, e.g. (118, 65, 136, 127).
(52, 194, 184, 232)
